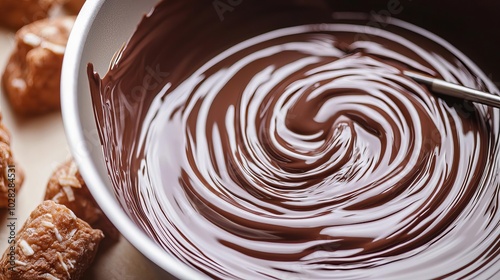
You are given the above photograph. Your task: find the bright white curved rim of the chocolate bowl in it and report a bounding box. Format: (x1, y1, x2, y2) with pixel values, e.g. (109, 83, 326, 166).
(61, 0, 206, 279)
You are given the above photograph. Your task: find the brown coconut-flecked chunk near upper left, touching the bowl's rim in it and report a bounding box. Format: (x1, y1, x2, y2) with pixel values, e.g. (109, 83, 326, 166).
(0, 16, 75, 115)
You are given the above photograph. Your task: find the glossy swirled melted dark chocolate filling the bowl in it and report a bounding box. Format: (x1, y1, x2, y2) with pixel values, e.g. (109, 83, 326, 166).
(89, 1, 500, 279)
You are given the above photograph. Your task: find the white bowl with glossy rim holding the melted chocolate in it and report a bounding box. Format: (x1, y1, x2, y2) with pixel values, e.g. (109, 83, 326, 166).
(61, 0, 205, 279)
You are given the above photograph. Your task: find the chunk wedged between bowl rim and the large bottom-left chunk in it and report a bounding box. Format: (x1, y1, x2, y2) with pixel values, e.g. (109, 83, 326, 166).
(45, 160, 120, 241)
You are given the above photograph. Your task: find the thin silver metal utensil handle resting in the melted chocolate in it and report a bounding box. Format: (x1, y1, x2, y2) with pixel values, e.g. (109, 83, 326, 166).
(403, 71, 500, 108)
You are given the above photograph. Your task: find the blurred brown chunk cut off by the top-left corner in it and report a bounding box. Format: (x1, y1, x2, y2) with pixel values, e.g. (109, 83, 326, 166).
(0, 0, 58, 29)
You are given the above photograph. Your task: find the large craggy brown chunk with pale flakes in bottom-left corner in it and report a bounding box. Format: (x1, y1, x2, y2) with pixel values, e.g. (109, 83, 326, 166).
(0, 201, 104, 279)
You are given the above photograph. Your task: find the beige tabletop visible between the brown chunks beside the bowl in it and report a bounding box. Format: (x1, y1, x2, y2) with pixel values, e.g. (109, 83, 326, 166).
(0, 24, 176, 280)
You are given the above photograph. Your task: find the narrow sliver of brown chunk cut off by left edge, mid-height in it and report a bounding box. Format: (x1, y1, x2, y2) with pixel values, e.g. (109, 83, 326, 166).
(0, 114, 24, 208)
